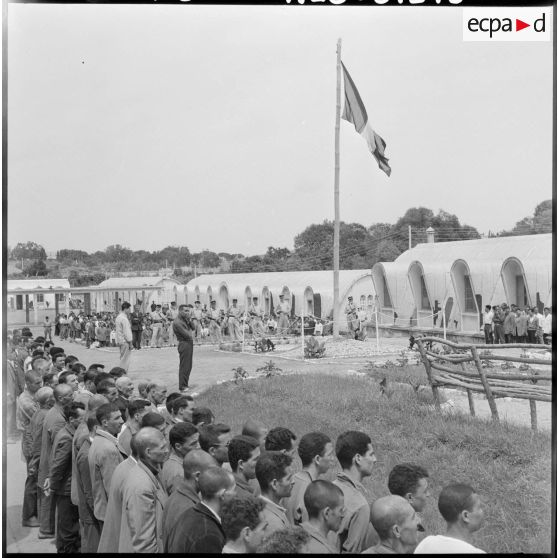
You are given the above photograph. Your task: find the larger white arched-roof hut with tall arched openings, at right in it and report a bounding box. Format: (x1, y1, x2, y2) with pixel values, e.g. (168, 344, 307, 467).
(372, 234, 553, 332)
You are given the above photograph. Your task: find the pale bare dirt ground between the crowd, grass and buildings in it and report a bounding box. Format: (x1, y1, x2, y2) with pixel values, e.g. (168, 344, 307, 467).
(4, 339, 552, 553)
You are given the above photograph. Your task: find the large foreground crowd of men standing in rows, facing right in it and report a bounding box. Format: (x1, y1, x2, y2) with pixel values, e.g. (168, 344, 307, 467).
(8, 328, 490, 554)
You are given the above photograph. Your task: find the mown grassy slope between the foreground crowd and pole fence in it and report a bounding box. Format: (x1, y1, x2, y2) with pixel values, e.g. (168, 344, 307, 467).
(198, 375, 551, 553)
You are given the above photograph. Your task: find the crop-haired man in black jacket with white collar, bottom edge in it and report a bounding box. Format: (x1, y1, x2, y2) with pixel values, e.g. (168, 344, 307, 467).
(164, 467, 236, 554)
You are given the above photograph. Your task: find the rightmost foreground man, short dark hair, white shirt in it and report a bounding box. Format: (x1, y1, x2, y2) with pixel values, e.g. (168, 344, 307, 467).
(415, 484, 486, 554)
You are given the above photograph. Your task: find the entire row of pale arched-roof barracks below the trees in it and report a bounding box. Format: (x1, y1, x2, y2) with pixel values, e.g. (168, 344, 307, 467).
(8, 234, 553, 340)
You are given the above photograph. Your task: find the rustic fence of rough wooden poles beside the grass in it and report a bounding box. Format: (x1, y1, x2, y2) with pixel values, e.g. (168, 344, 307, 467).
(416, 337, 552, 430)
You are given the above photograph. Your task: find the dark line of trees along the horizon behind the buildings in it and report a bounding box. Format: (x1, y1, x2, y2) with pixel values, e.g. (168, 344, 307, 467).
(8, 200, 552, 286)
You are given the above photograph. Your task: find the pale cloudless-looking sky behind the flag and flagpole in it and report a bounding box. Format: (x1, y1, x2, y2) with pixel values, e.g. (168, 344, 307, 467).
(8, 4, 552, 255)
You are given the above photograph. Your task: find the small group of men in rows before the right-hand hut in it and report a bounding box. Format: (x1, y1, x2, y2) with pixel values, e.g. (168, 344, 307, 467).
(483, 302, 552, 345)
